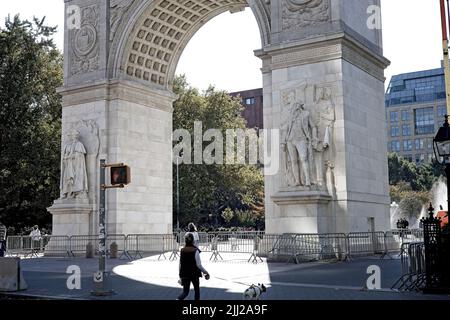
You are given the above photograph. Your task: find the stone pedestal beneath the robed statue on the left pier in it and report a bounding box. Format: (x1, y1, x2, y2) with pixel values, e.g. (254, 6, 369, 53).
(47, 198, 94, 236)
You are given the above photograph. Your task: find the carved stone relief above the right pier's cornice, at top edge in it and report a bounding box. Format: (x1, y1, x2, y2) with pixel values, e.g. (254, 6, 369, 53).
(282, 0, 330, 30)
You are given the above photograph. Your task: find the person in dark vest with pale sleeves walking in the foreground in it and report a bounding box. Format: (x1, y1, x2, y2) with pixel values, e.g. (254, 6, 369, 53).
(177, 232, 209, 300)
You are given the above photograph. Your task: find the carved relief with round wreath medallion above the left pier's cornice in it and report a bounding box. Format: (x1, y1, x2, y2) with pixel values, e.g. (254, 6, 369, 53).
(69, 5, 100, 75)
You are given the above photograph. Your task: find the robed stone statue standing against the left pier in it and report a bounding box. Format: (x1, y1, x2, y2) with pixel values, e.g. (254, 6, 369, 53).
(61, 131, 88, 199)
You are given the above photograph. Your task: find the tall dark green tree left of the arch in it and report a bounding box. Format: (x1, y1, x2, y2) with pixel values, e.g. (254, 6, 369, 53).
(0, 16, 63, 230)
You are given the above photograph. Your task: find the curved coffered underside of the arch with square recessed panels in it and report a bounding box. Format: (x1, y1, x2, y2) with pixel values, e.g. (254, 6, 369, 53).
(114, 0, 270, 89)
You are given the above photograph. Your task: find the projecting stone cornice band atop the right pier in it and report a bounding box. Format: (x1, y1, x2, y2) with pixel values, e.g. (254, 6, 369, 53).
(255, 32, 390, 81)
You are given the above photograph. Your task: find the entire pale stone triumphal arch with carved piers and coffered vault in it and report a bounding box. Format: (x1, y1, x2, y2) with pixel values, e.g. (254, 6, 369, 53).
(48, 0, 389, 235)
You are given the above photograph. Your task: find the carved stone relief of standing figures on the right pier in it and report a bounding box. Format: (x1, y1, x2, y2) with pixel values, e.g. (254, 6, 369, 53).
(281, 84, 335, 193)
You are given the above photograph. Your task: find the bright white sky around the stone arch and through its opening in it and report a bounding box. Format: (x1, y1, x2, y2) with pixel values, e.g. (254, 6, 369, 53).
(0, 0, 442, 91)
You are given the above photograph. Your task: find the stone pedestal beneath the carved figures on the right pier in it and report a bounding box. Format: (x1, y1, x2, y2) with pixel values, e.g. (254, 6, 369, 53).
(267, 189, 335, 233)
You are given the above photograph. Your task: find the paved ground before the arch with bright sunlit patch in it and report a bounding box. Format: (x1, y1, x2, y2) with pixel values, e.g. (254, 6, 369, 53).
(1, 253, 450, 300)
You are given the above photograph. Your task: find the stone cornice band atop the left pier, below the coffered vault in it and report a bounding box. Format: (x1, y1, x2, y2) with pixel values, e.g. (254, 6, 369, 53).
(58, 80, 177, 112)
